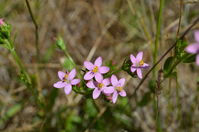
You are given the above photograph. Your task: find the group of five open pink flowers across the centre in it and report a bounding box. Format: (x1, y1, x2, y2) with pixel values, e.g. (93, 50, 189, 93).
(54, 52, 149, 103)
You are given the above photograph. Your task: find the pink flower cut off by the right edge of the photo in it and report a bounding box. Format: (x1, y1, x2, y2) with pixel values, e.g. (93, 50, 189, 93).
(185, 30, 199, 66)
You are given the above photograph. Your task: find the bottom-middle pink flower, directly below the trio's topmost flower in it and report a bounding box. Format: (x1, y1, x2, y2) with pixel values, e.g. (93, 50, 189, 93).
(86, 78, 114, 99)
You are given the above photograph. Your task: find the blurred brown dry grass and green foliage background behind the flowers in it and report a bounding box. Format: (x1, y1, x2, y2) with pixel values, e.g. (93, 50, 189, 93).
(0, 0, 199, 132)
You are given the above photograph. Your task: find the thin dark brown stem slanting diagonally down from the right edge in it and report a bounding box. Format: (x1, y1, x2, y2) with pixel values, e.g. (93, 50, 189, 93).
(132, 17, 199, 96)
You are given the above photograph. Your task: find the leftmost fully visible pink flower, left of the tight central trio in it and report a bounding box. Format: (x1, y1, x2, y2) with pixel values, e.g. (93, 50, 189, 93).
(53, 69, 80, 95)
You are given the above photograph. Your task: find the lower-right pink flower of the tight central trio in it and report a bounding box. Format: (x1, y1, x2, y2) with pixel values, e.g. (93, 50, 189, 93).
(111, 75, 126, 103)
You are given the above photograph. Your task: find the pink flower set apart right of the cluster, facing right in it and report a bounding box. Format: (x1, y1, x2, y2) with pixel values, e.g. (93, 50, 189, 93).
(130, 52, 149, 79)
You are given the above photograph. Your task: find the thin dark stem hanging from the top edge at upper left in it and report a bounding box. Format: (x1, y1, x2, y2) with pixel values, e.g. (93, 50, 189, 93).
(26, 0, 40, 61)
